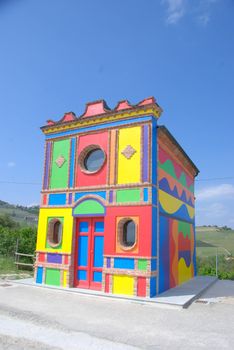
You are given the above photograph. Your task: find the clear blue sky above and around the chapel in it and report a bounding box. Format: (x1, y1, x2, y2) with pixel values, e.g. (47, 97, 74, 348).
(0, 0, 234, 227)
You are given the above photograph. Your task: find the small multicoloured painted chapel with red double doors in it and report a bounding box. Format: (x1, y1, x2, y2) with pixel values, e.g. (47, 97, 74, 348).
(35, 97, 199, 298)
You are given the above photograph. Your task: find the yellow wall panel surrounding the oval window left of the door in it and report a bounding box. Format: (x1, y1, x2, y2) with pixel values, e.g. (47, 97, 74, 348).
(37, 208, 73, 253)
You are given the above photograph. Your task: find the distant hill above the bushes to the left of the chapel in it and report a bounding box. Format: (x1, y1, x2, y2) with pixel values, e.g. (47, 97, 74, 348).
(0, 200, 39, 226)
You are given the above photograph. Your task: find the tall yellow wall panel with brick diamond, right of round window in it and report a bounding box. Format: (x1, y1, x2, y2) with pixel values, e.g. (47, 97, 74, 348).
(117, 126, 141, 184)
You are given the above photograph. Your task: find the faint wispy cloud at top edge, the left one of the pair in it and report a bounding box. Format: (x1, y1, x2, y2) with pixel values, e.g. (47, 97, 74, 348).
(162, 0, 185, 24)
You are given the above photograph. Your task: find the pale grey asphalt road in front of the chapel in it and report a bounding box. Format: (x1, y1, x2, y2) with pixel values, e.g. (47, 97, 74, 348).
(0, 281, 234, 350)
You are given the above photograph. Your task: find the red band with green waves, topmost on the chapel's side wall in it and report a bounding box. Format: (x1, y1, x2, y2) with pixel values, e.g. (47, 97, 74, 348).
(158, 147, 194, 192)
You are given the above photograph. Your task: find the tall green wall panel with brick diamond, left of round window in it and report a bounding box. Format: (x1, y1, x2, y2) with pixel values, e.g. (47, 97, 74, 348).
(50, 140, 70, 188)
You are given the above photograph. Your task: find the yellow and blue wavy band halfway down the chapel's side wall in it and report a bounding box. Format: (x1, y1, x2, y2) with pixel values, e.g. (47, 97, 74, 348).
(158, 190, 194, 222)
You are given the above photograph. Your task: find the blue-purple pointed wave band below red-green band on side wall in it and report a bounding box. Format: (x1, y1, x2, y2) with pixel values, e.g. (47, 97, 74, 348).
(159, 177, 194, 207)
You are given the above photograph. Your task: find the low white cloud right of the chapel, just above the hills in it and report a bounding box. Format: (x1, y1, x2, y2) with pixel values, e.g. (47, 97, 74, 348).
(196, 184, 234, 201)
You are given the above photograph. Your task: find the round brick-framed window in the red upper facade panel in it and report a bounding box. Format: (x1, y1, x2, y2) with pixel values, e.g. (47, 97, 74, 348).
(79, 145, 106, 173)
